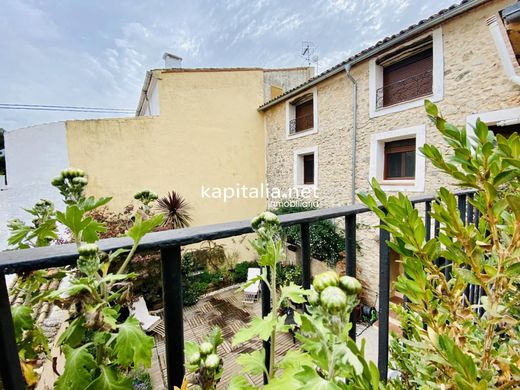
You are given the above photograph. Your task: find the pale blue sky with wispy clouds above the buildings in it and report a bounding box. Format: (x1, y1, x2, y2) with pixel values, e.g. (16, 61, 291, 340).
(0, 0, 456, 130)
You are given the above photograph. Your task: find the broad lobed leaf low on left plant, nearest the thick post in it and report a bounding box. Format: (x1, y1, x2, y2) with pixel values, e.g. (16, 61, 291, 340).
(114, 317, 153, 367)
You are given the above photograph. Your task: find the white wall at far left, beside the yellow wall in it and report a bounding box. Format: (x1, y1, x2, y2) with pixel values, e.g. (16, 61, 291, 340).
(0, 122, 69, 250)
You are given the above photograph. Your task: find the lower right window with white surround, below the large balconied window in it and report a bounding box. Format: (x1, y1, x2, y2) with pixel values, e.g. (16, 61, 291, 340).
(369, 125, 426, 192)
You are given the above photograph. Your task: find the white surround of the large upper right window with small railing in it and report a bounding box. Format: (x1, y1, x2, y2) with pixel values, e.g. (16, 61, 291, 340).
(368, 27, 444, 118)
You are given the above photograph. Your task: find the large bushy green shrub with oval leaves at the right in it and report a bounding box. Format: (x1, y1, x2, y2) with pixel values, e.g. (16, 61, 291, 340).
(360, 101, 520, 390)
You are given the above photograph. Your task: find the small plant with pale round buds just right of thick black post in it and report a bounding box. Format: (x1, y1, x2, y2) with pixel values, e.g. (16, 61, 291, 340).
(185, 327, 224, 390)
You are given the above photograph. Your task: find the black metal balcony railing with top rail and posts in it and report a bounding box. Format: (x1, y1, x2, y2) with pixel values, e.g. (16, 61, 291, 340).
(0, 191, 481, 390)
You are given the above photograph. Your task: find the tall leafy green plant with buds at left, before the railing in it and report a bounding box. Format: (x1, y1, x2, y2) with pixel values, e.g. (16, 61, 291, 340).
(10, 169, 163, 389)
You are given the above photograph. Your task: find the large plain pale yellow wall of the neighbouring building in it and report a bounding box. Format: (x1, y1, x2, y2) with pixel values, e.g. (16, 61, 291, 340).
(67, 70, 266, 226)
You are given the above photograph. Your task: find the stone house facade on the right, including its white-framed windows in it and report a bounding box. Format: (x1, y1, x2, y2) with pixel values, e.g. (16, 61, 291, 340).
(259, 0, 520, 303)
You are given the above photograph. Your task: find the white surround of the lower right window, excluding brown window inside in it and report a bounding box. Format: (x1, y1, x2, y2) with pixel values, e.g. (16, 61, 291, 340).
(369, 125, 426, 192)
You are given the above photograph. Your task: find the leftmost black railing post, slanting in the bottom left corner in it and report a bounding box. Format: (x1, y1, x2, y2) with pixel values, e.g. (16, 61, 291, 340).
(0, 272, 26, 390)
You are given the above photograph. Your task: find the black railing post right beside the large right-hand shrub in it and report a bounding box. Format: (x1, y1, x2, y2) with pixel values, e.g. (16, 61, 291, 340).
(377, 221, 390, 383)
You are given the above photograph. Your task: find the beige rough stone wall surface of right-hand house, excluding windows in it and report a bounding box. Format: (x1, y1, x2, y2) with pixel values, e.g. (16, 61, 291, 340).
(265, 0, 520, 303)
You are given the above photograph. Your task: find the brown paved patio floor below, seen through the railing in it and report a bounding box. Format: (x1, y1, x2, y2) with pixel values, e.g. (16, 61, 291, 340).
(150, 288, 378, 389)
